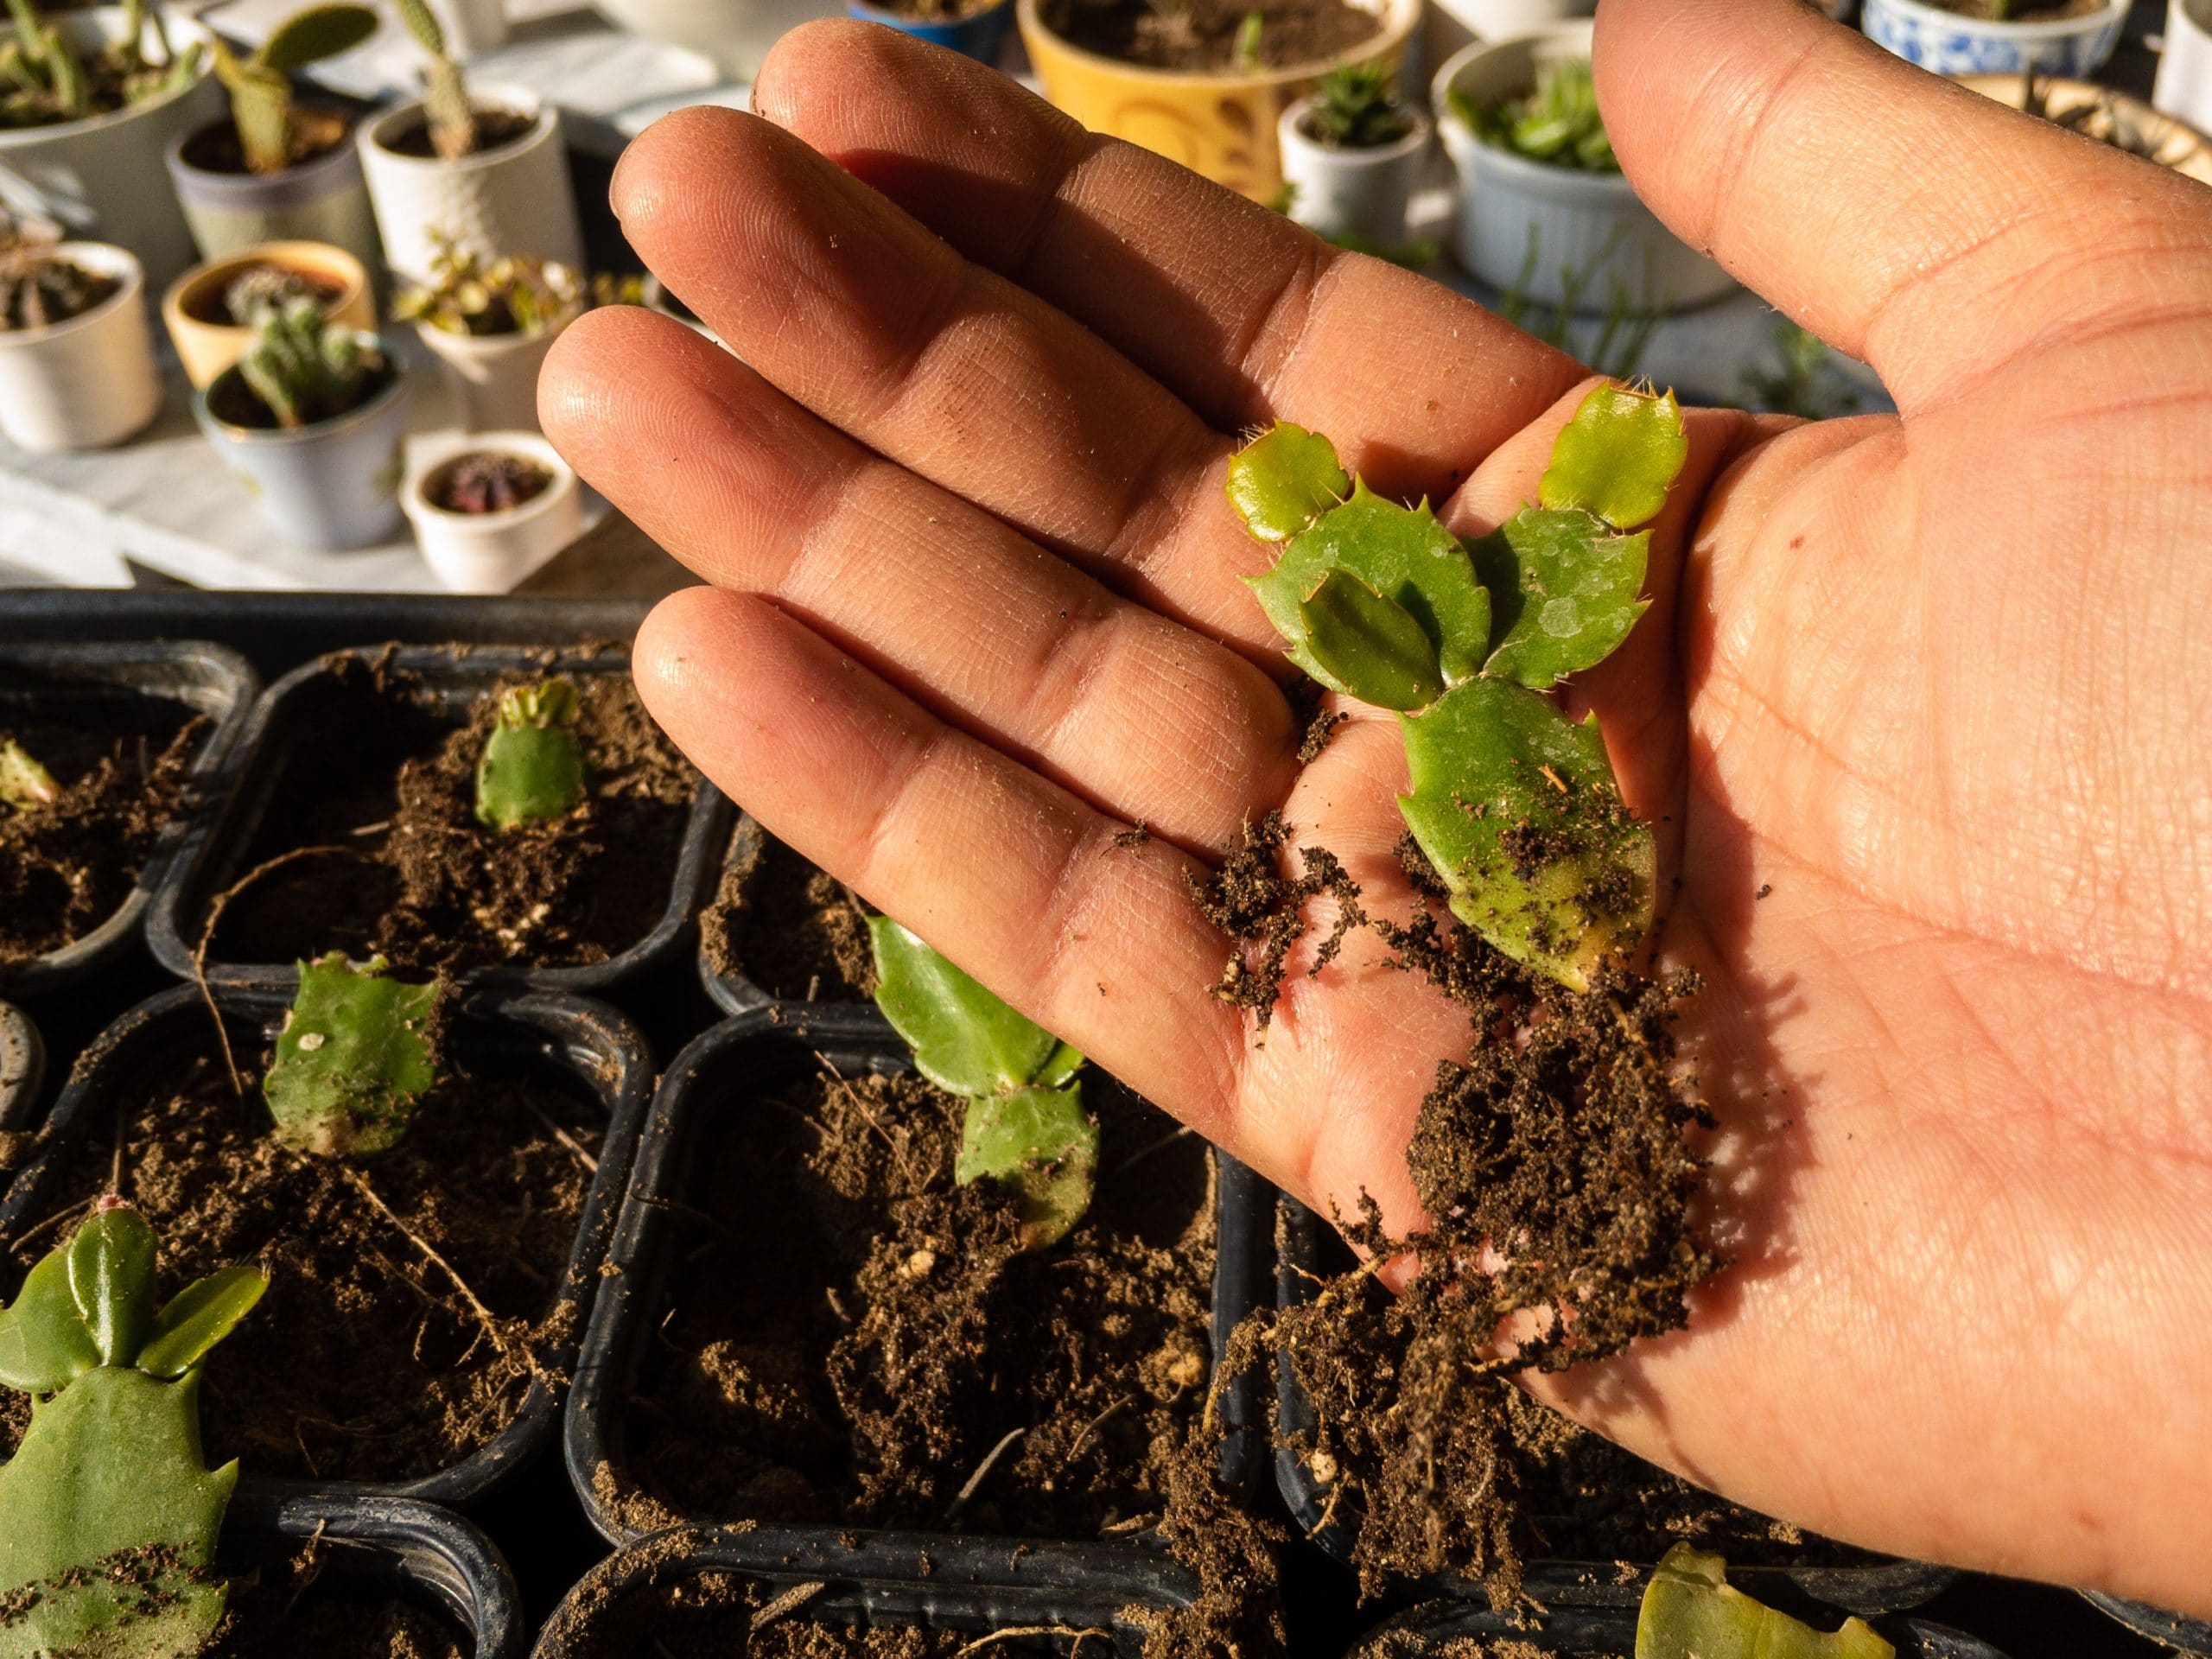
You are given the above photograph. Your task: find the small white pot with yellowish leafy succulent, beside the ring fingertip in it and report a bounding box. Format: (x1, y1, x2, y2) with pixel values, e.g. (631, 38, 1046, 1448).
(391, 234, 586, 431)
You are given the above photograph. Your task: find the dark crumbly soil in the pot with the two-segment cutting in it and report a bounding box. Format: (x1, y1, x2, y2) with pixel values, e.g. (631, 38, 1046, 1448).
(601, 1075, 1214, 1537)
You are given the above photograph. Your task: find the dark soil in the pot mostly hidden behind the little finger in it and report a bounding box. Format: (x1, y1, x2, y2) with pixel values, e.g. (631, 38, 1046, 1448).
(699, 836, 876, 1002)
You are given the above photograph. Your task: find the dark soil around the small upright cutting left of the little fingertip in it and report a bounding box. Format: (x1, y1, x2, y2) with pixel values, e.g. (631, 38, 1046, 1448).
(207, 657, 699, 973)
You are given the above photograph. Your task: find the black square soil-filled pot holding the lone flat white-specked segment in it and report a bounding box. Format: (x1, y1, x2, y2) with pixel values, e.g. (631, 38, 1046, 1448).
(0, 984, 652, 1506)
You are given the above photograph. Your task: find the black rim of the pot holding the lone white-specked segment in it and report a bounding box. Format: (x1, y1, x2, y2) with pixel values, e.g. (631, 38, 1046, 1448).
(0, 984, 652, 1509)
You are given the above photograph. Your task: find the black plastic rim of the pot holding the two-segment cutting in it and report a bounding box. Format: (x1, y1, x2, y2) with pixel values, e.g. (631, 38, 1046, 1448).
(566, 1008, 1265, 1574)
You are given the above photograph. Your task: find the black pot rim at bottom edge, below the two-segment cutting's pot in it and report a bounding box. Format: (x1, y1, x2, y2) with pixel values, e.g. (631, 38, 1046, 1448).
(531, 1526, 1190, 1659)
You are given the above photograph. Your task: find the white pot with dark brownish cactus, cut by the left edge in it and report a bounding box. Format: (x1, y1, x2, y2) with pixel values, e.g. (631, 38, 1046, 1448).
(0, 241, 162, 455)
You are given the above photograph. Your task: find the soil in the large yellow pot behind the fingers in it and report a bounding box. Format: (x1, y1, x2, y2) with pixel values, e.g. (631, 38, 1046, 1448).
(1042, 0, 1380, 71)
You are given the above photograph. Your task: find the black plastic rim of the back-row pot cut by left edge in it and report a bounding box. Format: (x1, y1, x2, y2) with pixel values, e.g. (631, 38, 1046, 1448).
(0, 626, 259, 998)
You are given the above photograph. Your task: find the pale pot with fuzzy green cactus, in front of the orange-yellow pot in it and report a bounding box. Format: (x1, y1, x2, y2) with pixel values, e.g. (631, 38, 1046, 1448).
(193, 340, 407, 549)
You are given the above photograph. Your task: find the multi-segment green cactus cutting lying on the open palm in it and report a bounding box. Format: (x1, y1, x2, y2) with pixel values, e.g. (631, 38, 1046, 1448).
(1228, 385, 1688, 991)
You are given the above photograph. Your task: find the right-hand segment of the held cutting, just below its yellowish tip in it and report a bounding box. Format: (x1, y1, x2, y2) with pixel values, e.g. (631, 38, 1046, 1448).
(1473, 506, 1650, 690)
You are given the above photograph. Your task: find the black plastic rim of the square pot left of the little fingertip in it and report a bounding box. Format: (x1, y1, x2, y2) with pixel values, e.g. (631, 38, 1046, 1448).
(149, 646, 730, 995)
